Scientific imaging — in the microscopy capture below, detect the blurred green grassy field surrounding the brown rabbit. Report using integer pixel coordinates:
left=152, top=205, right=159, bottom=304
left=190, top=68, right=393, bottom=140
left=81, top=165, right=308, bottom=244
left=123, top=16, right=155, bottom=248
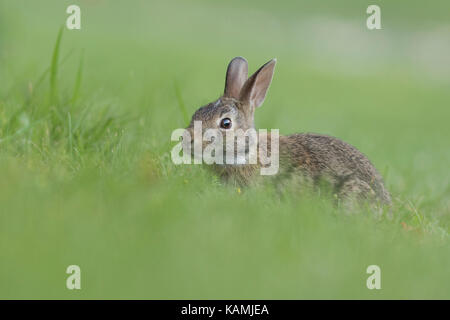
left=0, top=0, right=450, bottom=299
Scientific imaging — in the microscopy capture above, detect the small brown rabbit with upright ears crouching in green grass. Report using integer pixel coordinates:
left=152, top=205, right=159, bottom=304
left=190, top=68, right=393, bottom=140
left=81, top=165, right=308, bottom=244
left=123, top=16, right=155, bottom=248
left=185, top=57, right=391, bottom=204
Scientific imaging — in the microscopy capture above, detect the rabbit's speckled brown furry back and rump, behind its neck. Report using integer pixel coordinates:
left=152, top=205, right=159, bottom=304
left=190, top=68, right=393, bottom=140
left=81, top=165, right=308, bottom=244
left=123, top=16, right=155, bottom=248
left=280, top=133, right=391, bottom=203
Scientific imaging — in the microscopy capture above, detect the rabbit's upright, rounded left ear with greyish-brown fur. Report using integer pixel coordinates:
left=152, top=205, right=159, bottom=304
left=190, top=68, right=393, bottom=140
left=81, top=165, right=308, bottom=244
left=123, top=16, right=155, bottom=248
left=224, top=57, right=248, bottom=99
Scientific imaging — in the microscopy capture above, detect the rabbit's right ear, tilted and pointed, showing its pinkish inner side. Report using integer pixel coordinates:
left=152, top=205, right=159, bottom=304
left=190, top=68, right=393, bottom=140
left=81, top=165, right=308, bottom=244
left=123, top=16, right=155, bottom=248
left=239, top=59, right=277, bottom=108
